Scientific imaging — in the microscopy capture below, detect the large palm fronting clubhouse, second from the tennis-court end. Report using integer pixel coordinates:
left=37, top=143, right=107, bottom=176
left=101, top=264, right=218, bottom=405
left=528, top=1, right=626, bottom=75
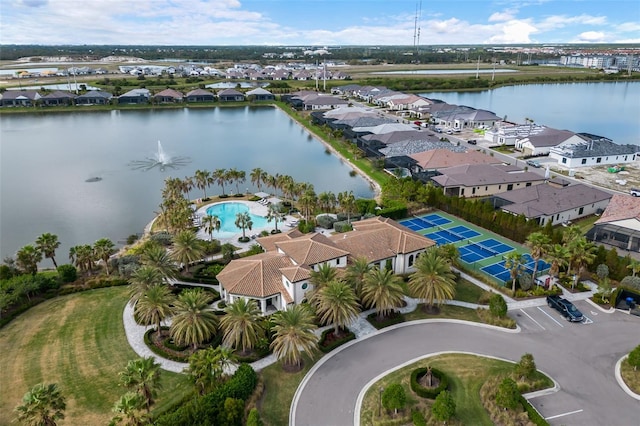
left=362, top=268, right=403, bottom=321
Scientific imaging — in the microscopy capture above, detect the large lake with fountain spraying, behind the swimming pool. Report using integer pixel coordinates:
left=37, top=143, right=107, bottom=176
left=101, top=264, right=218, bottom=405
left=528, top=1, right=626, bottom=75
left=0, top=107, right=373, bottom=260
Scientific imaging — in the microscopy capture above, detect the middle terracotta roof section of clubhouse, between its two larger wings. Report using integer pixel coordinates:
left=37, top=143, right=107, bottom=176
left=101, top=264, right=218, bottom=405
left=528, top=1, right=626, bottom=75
left=275, top=233, right=349, bottom=266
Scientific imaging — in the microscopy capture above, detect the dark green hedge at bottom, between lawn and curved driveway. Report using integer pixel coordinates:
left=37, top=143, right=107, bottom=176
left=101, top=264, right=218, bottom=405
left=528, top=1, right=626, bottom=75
left=154, top=364, right=258, bottom=426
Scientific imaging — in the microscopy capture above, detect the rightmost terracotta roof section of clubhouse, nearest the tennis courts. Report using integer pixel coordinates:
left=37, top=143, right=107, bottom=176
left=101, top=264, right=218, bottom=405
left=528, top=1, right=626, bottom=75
left=330, top=217, right=436, bottom=262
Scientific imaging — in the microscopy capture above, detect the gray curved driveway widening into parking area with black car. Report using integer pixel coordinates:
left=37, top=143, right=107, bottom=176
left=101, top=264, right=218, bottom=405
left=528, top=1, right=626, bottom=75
left=290, top=313, right=640, bottom=426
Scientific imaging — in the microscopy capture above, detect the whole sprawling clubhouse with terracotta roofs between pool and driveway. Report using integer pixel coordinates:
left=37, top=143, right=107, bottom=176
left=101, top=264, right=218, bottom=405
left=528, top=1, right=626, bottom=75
left=217, top=217, right=435, bottom=314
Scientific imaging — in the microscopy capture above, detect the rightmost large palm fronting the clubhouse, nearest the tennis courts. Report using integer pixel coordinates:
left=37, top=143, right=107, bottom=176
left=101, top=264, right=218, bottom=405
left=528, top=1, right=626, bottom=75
left=409, top=250, right=456, bottom=310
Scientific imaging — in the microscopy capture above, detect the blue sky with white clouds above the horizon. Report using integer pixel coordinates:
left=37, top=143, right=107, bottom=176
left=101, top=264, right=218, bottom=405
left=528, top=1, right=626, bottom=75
left=0, top=0, right=640, bottom=46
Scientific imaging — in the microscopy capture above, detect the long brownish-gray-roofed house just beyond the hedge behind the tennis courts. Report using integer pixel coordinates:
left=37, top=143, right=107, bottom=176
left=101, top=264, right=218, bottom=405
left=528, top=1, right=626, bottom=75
left=493, top=183, right=612, bottom=226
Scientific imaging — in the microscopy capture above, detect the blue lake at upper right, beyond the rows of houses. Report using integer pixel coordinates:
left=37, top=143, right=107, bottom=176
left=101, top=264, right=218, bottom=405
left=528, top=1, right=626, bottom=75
left=420, top=82, right=640, bottom=145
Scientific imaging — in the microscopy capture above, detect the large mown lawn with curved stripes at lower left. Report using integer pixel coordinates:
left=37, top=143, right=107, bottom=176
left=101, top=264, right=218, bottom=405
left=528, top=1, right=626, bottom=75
left=0, top=287, right=191, bottom=425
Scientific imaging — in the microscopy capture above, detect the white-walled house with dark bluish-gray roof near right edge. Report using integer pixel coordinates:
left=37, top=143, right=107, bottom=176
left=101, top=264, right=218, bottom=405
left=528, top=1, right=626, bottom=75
left=549, top=133, right=640, bottom=168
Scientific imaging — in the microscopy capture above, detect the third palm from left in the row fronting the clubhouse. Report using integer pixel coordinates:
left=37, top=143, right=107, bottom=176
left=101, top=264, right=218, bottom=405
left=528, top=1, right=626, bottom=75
left=220, top=297, right=264, bottom=355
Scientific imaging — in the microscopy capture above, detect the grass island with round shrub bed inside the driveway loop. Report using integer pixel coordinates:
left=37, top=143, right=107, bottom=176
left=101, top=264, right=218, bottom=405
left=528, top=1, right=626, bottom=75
left=360, top=354, right=551, bottom=426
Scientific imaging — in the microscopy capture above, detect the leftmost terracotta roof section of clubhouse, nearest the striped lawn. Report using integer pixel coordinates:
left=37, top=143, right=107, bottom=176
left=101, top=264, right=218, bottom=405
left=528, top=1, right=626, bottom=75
left=217, top=252, right=294, bottom=303
